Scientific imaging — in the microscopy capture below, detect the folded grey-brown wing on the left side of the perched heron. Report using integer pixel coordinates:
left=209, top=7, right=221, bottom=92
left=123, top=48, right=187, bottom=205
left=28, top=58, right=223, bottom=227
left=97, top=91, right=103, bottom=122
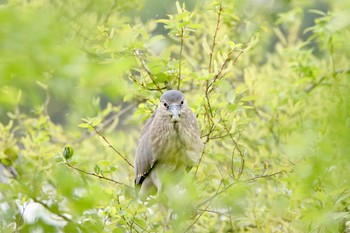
left=134, top=110, right=157, bottom=185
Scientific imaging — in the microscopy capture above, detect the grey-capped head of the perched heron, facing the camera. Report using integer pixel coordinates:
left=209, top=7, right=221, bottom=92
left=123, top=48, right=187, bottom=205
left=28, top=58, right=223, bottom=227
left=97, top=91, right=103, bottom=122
left=160, top=90, right=186, bottom=122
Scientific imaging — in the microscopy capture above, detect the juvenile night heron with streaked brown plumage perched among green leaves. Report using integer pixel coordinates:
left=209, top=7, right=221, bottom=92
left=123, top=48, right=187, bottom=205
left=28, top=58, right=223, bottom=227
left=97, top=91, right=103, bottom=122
left=134, top=90, right=203, bottom=201
